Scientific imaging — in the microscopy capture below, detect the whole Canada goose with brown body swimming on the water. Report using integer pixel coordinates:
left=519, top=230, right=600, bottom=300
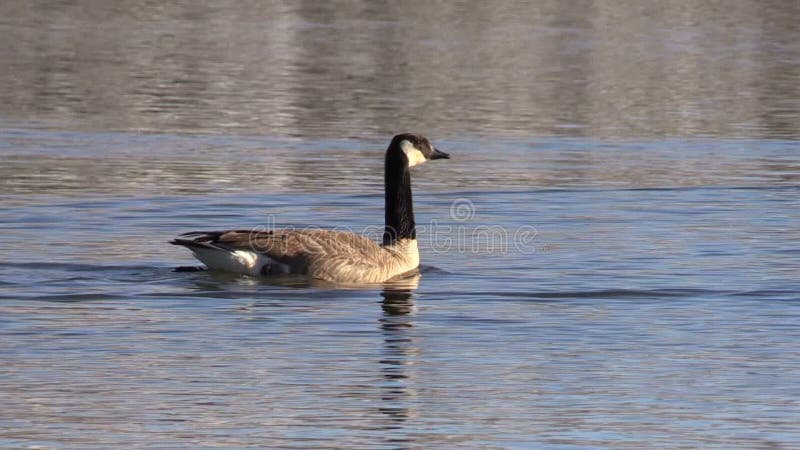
left=170, top=133, right=450, bottom=283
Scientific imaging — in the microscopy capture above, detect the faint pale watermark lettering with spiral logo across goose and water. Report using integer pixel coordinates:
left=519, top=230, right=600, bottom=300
left=250, top=198, right=537, bottom=253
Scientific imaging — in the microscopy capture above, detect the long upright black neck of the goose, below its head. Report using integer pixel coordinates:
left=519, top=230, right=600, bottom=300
left=383, top=152, right=417, bottom=245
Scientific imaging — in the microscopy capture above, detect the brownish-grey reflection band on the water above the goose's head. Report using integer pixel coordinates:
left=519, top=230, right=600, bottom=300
left=0, top=0, right=800, bottom=138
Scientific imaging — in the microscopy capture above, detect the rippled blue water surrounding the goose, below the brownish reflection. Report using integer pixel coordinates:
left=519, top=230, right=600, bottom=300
left=0, top=130, right=800, bottom=448
